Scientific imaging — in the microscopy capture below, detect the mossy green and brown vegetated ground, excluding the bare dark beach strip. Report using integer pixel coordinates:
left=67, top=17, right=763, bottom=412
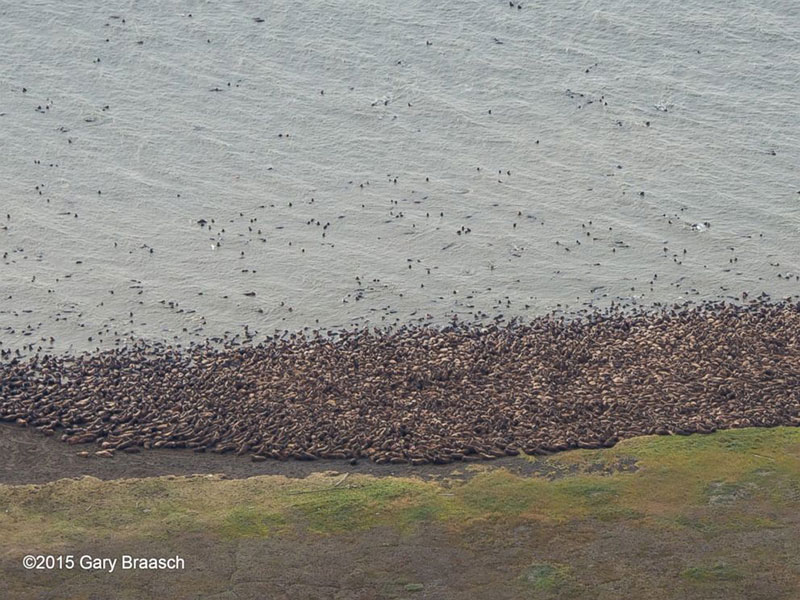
left=0, top=428, right=800, bottom=598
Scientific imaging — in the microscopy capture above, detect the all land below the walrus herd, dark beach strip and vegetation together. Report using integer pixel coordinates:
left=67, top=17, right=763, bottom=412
left=0, top=427, right=800, bottom=600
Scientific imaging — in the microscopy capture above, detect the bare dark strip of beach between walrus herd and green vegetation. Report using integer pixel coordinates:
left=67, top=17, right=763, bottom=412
left=0, top=423, right=797, bottom=486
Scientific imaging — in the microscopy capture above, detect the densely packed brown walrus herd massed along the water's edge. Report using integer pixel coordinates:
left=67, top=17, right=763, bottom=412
left=0, top=301, right=800, bottom=464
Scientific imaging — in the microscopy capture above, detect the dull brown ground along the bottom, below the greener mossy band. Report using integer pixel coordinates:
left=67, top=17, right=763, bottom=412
left=0, top=521, right=800, bottom=600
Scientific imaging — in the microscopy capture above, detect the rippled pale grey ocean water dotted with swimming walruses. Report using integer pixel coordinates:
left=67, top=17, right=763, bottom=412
left=0, top=0, right=800, bottom=352
